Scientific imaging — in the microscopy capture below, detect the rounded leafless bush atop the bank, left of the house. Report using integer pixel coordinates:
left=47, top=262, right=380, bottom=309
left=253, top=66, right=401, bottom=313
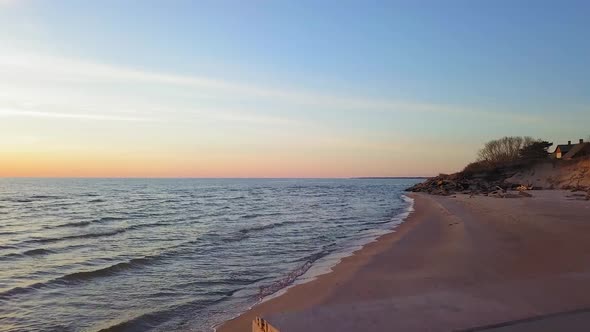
left=478, top=136, right=537, bottom=165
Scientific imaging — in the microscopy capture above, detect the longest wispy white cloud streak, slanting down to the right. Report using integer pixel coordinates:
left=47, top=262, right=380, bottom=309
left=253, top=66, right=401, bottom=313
left=0, top=54, right=543, bottom=123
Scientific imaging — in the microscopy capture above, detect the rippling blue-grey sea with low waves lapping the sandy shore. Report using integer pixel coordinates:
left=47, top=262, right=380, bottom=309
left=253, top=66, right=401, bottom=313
left=0, top=179, right=416, bottom=331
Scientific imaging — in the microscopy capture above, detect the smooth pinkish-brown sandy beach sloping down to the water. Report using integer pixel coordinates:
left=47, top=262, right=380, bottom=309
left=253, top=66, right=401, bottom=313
left=217, top=191, right=590, bottom=332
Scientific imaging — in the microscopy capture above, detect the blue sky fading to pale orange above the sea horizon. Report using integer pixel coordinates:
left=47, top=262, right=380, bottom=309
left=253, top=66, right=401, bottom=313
left=0, top=0, right=590, bottom=177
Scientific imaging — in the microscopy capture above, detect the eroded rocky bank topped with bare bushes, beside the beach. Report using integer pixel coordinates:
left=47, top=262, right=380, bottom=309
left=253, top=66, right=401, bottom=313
left=408, top=136, right=590, bottom=200
